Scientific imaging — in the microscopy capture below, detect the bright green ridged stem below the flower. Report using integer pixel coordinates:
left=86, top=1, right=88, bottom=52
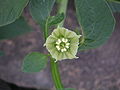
left=50, top=58, right=63, bottom=90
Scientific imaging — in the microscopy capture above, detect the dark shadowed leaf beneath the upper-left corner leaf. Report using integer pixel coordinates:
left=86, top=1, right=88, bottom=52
left=0, top=17, right=32, bottom=40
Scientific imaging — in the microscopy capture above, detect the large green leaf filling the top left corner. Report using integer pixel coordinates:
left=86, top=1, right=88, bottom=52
left=0, top=0, right=29, bottom=26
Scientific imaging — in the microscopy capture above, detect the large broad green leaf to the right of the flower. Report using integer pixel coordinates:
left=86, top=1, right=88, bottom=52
left=75, top=0, right=115, bottom=50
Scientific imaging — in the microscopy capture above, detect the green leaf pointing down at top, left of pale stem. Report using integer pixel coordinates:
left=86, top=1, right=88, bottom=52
left=29, top=0, right=55, bottom=29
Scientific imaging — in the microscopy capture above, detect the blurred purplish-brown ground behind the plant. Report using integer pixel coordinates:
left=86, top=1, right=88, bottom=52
left=0, top=0, right=120, bottom=90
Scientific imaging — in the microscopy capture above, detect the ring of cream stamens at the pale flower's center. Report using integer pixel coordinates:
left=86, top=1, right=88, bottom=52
left=56, top=38, right=70, bottom=52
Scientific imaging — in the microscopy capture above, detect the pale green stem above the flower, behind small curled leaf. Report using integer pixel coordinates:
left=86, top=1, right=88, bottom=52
left=58, top=0, right=68, bottom=26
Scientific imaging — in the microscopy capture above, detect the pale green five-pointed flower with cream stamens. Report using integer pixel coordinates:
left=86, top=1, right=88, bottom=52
left=45, top=27, right=81, bottom=61
